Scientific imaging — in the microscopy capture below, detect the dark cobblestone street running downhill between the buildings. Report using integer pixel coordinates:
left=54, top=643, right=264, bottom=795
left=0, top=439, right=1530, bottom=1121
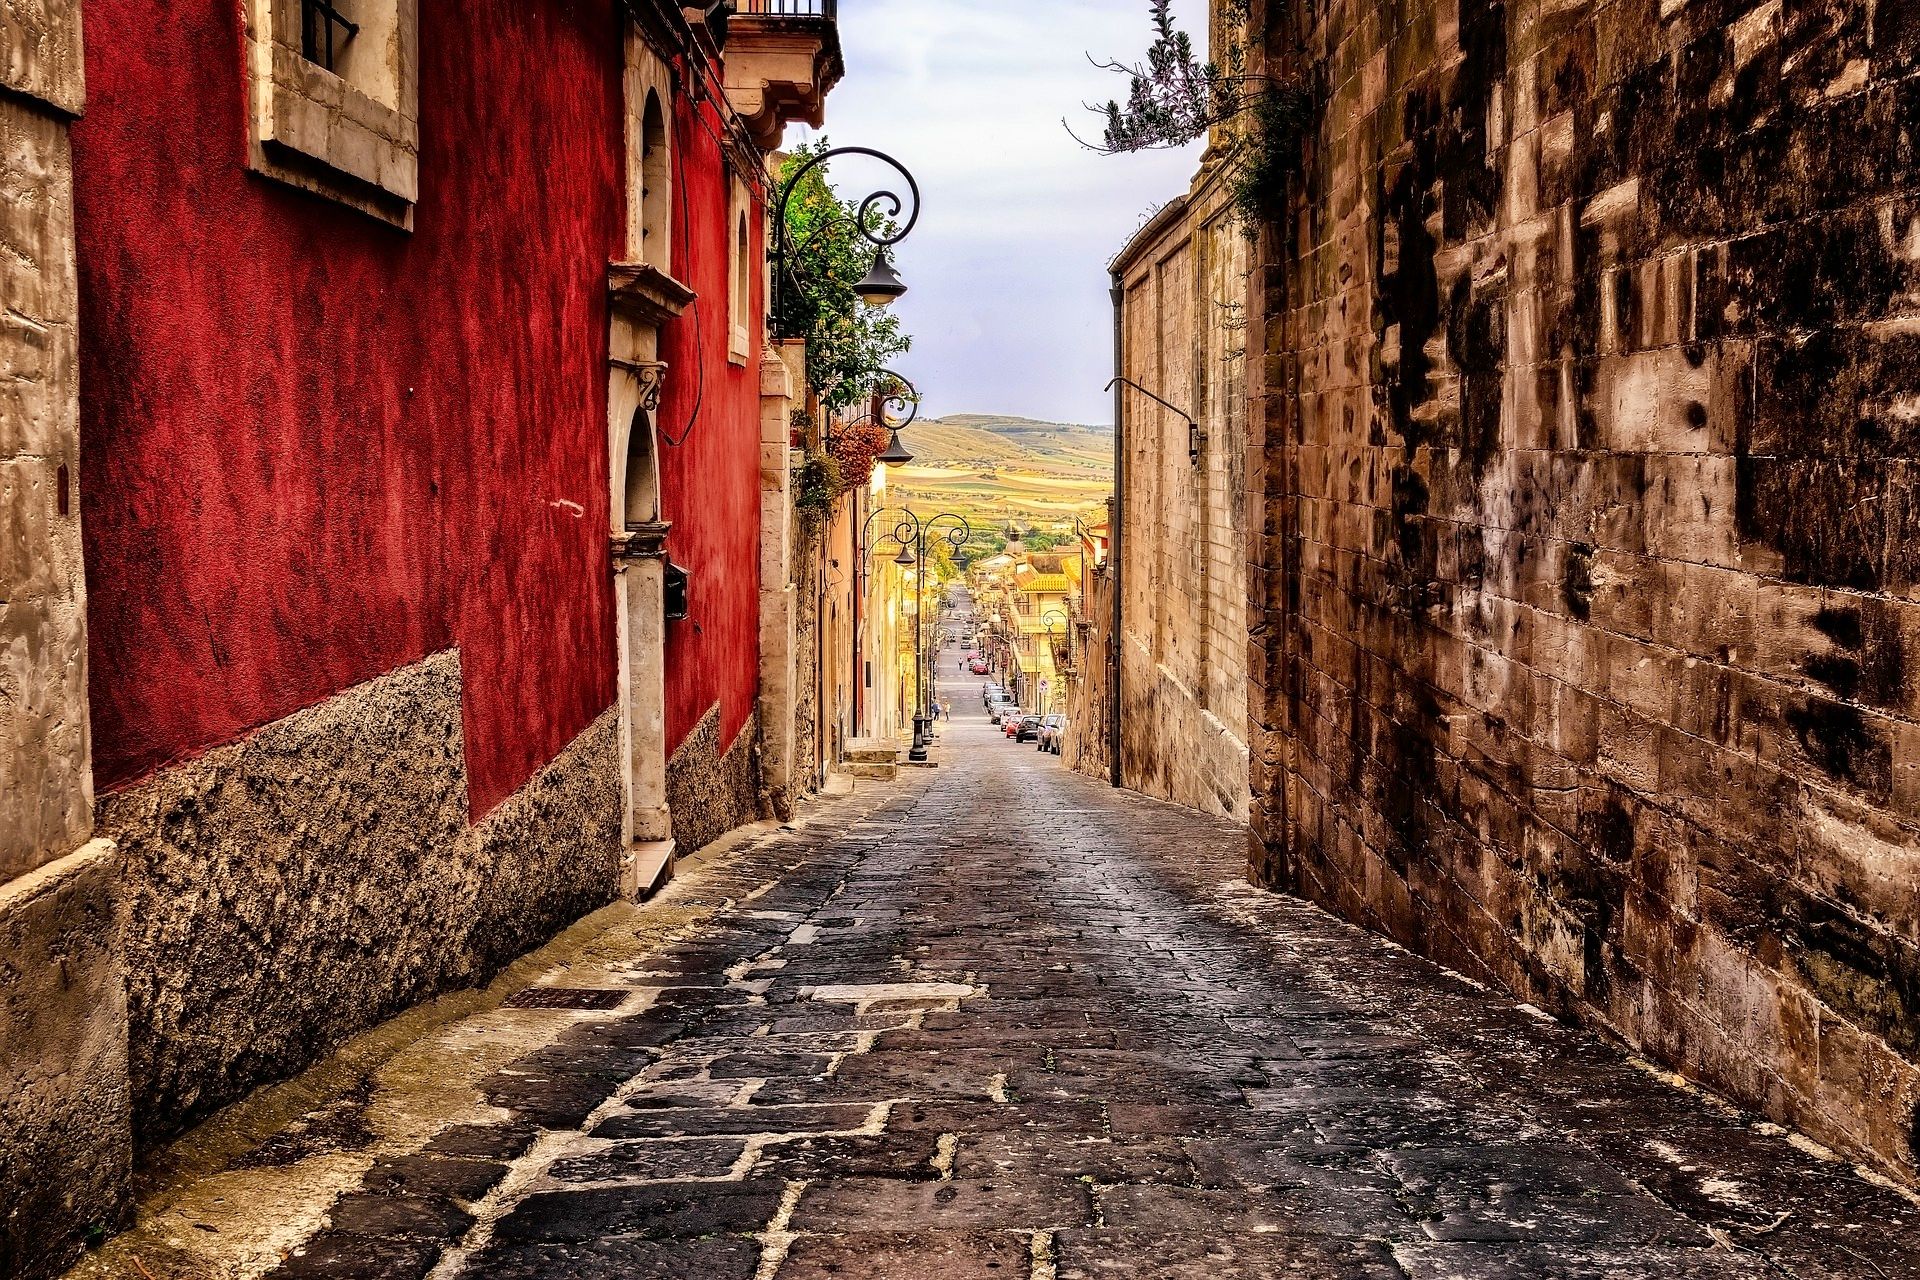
left=82, top=667, right=1920, bottom=1280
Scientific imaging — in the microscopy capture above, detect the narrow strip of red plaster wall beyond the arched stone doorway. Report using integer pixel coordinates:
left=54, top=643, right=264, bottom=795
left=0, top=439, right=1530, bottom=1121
left=659, top=104, right=766, bottom=750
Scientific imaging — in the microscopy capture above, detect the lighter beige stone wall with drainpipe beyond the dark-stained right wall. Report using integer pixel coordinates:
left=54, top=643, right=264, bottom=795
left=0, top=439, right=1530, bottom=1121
left=1114, top=167, right=1248, bottom=819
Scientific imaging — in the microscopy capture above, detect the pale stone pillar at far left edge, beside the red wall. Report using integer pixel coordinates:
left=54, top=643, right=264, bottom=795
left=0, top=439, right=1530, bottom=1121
left=0, top=0, right=132, bottom=1280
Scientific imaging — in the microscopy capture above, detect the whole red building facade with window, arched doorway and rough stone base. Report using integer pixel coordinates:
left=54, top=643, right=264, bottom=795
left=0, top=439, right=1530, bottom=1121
left=0, top=0, right=839, bottom=1274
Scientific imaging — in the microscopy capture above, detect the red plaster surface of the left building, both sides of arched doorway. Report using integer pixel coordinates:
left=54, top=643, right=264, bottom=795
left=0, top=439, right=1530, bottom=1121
left=75, top=0, right=756, bottom=816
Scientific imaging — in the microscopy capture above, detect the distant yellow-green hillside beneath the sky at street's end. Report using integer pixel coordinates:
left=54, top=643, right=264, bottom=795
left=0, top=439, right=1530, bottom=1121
left=887, top=413, right=1114, bottom=545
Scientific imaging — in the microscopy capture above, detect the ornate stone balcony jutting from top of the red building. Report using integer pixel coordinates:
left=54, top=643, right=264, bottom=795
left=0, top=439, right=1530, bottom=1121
left=726, top=0, right=847, bottom=152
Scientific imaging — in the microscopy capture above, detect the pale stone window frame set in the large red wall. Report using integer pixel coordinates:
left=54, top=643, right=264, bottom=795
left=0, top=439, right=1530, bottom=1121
left=246, top=0, right=420, bottom=230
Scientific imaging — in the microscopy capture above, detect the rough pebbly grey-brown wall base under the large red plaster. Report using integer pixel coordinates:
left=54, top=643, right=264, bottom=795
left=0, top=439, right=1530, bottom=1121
left=100, top=652, right=622, bottom=1144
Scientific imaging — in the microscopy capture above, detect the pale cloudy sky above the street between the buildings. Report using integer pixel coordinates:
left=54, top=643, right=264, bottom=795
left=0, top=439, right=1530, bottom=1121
left=787, top=0, right=1206, bottom=422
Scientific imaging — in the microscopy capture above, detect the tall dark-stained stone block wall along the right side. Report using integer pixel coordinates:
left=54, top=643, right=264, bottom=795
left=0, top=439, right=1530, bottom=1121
left=1248, top=0, right=1920, bottom=1174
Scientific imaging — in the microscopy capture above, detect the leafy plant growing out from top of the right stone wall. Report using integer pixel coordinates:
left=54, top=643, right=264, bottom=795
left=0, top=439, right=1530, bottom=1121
left=1068, top=0, right=1311, bottom=226
